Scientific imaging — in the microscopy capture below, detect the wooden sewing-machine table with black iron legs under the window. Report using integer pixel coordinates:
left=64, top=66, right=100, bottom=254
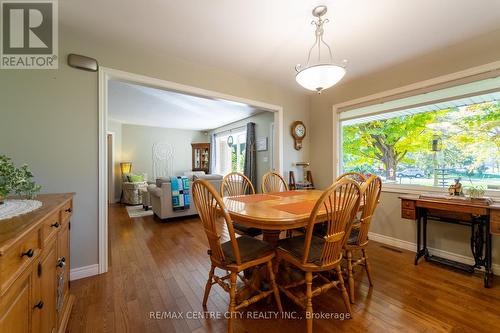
left=400, top=195, right=500, bottom=288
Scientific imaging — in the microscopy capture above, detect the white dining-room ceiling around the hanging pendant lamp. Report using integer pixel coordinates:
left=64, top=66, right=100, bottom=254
left=59, top=0, right=500, bottom=88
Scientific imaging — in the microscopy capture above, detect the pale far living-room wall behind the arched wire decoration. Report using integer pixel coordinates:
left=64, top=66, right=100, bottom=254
left=122, top=124, right=209, bottom=180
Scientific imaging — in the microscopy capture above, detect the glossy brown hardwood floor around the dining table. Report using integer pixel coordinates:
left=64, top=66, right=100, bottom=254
left=68, top=205, right=500, bottom=333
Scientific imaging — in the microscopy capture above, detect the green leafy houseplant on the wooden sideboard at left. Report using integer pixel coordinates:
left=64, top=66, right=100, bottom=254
left=0, top=155, right=41, bottom=204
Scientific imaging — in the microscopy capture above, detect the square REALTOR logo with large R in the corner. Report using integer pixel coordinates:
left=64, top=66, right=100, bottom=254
left=0, top=0, right=59, bottom=69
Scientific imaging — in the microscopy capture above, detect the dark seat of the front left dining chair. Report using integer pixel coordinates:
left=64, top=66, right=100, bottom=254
left=221, top=236, right=274, bottom=263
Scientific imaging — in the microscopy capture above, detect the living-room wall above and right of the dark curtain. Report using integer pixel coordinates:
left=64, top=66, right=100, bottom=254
left=209, top=111, right=276, bottom=192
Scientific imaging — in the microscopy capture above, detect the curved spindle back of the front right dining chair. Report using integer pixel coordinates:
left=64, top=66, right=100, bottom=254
left=302, top=179, right=361, bottom=266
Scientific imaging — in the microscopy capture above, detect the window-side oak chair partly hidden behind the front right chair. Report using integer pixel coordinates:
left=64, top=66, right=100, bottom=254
left=344, top=175, right=382, bottom=303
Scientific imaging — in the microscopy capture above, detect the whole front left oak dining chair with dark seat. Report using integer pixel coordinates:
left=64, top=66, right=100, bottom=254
left=192, top=179, right=283, bottom=332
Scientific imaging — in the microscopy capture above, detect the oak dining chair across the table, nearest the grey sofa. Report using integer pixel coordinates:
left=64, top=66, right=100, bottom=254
left=220, top=172, right=262, bottom=237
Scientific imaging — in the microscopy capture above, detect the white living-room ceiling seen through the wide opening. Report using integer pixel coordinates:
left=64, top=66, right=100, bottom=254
left=108, top=80, right=263, bottom=130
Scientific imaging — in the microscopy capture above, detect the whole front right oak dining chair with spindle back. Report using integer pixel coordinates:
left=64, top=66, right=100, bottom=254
left=275, top=179, right=361, bottom=333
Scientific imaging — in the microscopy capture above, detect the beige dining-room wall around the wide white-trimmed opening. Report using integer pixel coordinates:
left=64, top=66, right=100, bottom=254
left=0, top=18, right=309, bottom=268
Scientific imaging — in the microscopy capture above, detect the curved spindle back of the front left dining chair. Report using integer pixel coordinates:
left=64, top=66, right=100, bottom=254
left=192, top=179, right=241, bottom=265
